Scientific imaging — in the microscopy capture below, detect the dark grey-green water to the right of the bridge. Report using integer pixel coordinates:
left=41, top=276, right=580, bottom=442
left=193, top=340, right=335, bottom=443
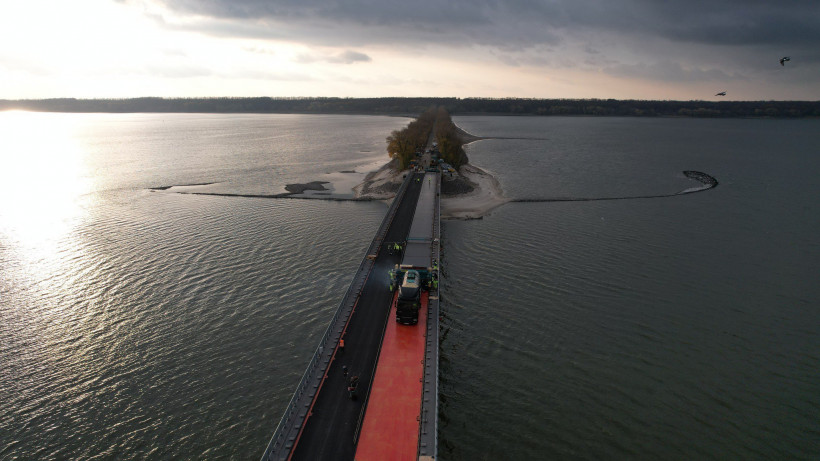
left=441, top=117, right=820, bottom=460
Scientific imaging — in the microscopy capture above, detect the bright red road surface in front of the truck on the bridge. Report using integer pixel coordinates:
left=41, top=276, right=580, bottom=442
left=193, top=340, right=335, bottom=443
left=354, top=291, right=428, bottom=461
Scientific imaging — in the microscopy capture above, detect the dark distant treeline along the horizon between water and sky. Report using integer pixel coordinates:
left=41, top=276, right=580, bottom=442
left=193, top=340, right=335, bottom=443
left=0, top=97, right=820, bottom=118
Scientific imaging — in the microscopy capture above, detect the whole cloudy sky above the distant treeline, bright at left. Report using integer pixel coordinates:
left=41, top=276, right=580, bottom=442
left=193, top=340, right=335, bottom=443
left=0, top=0, right=820, bottom=101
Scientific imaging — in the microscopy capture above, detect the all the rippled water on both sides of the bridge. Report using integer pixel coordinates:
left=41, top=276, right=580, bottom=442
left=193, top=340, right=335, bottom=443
left=0, top=113, right=820, bottom=460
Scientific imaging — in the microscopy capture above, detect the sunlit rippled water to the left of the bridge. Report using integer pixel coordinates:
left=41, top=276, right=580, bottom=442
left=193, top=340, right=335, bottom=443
left=0, top=113, right=406, bottom=459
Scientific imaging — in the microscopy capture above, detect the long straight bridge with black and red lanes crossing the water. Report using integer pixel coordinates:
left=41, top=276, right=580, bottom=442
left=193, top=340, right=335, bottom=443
left=262, top=165, right=441, bottom=461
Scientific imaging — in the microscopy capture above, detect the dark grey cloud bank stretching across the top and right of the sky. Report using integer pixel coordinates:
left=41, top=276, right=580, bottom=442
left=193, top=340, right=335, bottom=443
left=139, top=0, right=820, bottom=88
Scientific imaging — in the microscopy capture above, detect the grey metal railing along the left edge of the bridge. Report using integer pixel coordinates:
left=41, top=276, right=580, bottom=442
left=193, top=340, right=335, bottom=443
left=262, top=174, right=412, bottom=461
